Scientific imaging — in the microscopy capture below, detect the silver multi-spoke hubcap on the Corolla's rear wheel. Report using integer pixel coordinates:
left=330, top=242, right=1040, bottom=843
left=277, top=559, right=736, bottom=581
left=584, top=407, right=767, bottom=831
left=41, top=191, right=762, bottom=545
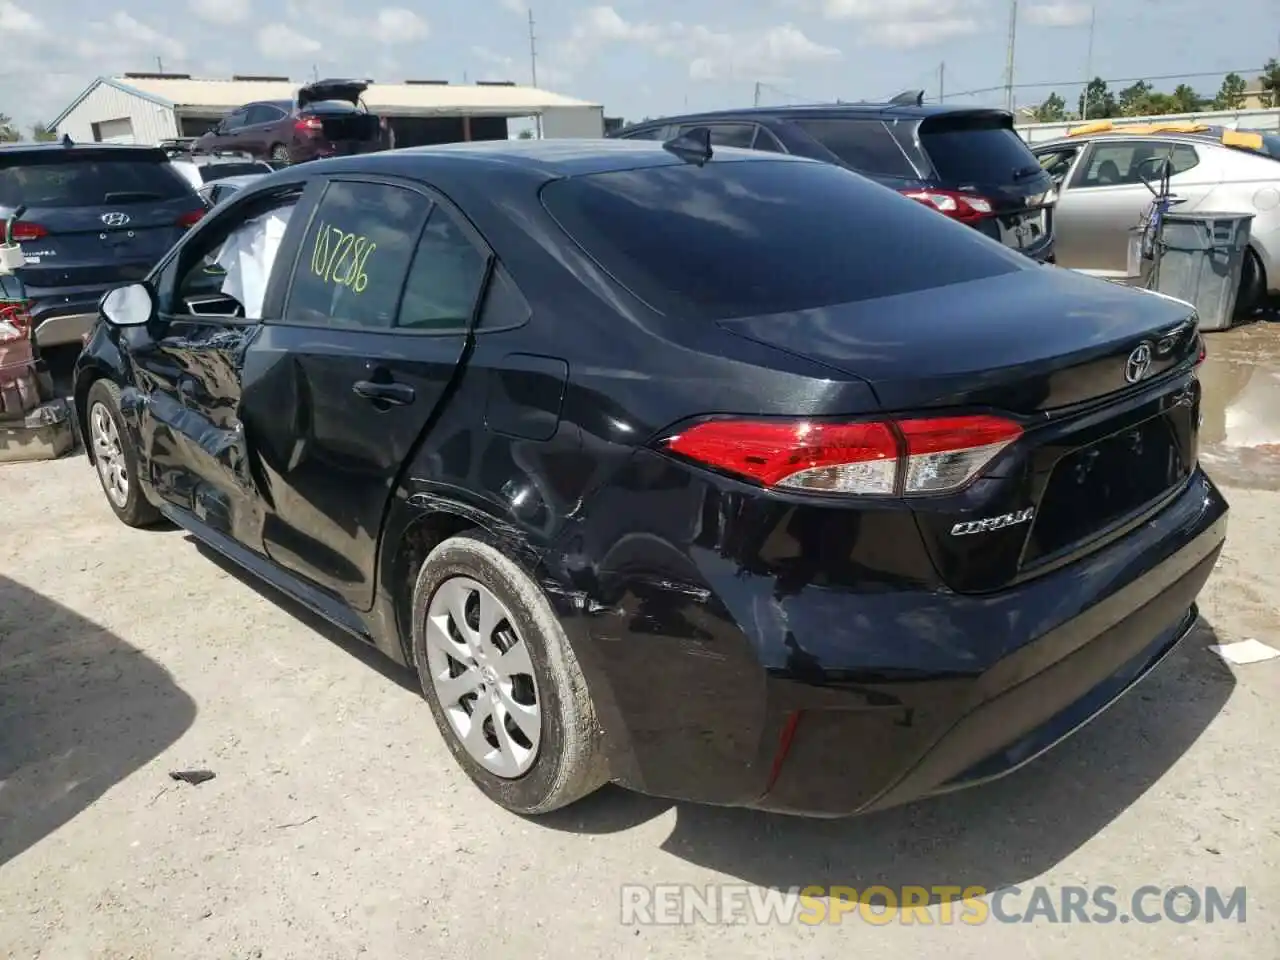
left=426, top=577, right=543, bottom=780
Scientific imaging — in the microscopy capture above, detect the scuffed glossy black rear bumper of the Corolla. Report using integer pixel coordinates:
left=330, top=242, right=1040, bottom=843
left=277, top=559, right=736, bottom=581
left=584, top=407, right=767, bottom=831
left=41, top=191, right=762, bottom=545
left=557, top=471, right=1228, bottom=817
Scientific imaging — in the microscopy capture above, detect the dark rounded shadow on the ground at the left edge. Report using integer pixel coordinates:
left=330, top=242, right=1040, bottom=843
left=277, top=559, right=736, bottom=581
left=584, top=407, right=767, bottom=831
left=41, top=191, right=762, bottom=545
left=0, top=576, right=196, bottom=865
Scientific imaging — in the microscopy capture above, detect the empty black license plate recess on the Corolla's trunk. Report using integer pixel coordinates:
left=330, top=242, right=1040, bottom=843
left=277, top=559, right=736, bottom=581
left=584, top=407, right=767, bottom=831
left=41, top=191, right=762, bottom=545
left=1023, top=406, right=1196, bottom=566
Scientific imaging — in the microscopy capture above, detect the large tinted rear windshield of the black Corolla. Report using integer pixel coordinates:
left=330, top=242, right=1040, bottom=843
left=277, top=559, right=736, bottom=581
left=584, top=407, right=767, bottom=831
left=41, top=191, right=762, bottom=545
left=543, top=159, right=1023, bottom=323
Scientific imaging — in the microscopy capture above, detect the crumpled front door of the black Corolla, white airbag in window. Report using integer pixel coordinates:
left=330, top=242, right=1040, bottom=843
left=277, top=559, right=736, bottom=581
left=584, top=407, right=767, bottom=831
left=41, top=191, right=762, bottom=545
left=123, top=179, right=321, bottom=550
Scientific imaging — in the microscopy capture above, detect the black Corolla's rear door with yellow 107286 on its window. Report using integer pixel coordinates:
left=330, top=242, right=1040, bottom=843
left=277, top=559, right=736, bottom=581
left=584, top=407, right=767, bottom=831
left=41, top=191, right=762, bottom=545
left=242, top=177, right=492, bottom=609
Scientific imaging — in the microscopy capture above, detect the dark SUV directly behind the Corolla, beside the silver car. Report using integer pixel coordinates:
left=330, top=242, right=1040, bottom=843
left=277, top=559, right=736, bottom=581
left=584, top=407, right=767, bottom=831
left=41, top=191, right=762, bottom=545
left=611, top=91, right=1057, bottom=262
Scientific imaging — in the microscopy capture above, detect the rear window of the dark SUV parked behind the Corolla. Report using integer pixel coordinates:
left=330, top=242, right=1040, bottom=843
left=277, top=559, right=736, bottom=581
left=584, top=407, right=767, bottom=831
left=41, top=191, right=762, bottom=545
left=920, top=115, right=1039, bottom=183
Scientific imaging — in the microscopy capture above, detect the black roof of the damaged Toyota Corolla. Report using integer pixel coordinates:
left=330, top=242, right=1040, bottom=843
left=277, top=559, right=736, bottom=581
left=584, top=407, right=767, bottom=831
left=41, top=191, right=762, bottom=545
left=307, top=138, right=817, bottom=179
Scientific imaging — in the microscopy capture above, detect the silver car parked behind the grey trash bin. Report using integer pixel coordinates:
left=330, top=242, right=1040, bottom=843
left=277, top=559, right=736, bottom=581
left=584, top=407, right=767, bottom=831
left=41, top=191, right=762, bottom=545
left=1032, top=123, right=1280, bottom=316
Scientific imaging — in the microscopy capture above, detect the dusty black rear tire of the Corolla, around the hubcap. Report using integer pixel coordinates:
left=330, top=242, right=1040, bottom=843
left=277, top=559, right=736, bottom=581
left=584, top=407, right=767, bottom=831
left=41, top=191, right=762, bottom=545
left=412, top=531, right=609, bottom=815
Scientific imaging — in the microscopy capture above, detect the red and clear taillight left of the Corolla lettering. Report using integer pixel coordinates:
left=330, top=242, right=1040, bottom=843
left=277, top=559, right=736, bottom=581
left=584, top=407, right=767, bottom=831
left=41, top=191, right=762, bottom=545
left=663, top=416, right=1023, bottom=497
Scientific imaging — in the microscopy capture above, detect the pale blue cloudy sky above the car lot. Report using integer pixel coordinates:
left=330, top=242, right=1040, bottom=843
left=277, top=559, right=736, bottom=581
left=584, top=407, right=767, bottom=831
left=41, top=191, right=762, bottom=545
left=0, top=0, right=1280, bottom=125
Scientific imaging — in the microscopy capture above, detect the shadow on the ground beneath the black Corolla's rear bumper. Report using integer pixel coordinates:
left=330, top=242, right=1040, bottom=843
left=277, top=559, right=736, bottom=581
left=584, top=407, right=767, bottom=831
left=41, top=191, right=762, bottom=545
left=536, top=620, right=1235, bottom=891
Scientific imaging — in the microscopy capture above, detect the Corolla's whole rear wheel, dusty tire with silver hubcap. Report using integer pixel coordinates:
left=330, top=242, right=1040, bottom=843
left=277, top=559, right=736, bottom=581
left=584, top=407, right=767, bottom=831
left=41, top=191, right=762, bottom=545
left=413, top=534, right=608, bottom=814
